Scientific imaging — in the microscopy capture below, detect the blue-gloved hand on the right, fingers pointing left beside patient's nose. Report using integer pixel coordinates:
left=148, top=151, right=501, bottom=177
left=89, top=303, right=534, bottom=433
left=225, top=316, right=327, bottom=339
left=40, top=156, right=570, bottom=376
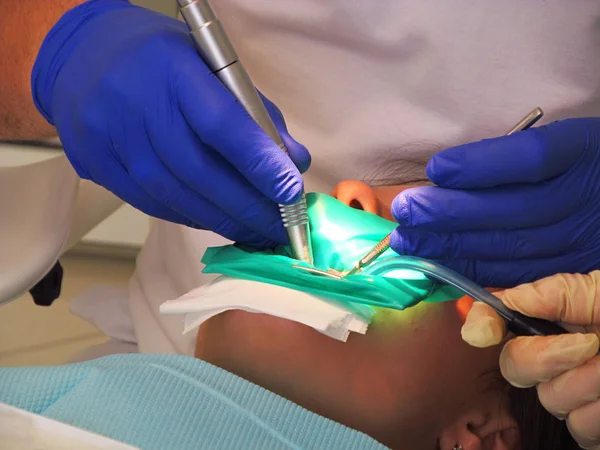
left=391, top=118, right=600, bottom=287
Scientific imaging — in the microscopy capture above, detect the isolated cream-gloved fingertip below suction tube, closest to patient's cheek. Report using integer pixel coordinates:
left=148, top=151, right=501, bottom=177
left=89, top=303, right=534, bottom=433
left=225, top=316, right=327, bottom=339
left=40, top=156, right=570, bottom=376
left=461, top=302, right=506, bottom=348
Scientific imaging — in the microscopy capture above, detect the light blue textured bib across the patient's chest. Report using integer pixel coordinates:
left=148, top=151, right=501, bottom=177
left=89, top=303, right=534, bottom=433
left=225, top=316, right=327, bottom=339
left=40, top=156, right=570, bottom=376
left=0, top=354, right=385, bottom=450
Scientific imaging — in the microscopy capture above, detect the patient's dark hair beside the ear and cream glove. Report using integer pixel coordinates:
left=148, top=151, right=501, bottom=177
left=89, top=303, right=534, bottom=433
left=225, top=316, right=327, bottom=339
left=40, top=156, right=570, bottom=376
left=508, top=386, right=580, bottom=450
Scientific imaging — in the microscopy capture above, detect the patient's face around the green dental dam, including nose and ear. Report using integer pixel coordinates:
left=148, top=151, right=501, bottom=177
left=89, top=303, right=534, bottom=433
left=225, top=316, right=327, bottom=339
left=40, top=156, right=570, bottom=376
left=196, top=184, right=517, bottom=450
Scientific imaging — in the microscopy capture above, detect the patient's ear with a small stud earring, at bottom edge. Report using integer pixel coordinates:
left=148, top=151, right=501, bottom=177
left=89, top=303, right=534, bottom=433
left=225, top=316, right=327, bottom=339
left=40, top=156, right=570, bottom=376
left=440, top=408, right=520, bottom=450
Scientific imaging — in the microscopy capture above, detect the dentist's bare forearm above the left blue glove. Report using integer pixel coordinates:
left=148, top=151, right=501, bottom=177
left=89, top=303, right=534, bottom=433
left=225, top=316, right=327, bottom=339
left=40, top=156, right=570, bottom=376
left=0, top=0, right=85, bottom=139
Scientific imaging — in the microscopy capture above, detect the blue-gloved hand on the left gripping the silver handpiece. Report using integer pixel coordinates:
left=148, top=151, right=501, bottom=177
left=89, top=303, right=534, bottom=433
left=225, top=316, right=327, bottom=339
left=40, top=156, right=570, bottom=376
left=32, top=0, right=310, bottom=250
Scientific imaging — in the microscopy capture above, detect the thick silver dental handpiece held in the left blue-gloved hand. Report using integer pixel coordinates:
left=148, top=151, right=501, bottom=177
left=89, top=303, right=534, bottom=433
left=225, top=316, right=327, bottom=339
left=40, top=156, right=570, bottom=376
left=177, top=0, right=313, bottom=264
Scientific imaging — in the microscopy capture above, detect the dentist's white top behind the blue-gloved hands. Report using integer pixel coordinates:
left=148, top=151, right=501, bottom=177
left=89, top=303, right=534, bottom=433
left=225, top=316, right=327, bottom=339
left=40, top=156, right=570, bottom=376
left=4, top=0, right=600, bottom=353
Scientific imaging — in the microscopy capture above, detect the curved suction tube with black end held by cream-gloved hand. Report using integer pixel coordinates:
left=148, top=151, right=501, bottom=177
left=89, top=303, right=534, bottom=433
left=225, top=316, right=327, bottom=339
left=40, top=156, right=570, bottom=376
left=363, top=256, right=568, bottom=336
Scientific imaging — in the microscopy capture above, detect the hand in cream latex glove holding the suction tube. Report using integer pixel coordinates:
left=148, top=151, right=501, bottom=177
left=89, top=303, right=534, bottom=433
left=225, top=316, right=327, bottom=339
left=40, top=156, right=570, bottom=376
left=462, top=271, right=600, bottom=449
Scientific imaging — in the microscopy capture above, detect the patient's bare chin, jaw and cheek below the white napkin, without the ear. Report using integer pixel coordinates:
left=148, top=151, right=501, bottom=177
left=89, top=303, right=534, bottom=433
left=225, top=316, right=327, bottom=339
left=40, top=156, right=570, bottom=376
left=196, top=303, right=497, bottom=448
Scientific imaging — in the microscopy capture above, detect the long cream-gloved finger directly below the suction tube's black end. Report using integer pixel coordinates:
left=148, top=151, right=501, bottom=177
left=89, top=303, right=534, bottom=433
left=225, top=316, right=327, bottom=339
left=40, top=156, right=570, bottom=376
left=500, top=334, right=599, bottom=387
